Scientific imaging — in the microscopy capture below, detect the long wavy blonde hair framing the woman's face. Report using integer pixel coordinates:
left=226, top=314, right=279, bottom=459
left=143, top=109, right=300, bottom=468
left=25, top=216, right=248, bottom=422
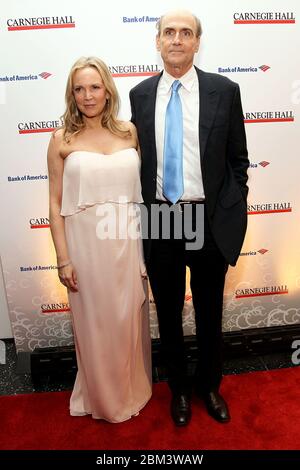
left=62, top=57, right=131, bottom=142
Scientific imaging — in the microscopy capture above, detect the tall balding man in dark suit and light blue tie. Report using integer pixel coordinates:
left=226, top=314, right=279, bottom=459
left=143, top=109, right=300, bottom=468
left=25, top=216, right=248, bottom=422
left=130, top=11, right=249, bottom=426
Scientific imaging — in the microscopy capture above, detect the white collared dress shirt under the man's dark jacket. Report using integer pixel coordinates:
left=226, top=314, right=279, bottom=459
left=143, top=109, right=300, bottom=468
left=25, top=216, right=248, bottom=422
left=155, top=67, right=205, bottom=201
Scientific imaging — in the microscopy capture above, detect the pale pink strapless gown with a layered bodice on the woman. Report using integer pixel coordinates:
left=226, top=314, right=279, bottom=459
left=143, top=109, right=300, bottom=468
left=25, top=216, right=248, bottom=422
left=61, top=148, right=152, bottom=423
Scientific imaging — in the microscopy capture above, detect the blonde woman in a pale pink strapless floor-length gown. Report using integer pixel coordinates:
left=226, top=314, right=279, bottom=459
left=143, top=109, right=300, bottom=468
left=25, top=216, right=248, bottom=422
left=48, top=57, right=151, bottom=423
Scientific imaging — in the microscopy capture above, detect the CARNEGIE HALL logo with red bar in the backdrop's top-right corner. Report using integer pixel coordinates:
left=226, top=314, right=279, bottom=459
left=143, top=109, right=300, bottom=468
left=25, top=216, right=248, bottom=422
left=233, top=11, right=296, bottom=24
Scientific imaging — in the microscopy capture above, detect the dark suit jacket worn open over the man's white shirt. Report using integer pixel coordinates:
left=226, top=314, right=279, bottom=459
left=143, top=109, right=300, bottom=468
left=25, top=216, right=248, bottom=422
left=130, top=67, right=249, bottom=266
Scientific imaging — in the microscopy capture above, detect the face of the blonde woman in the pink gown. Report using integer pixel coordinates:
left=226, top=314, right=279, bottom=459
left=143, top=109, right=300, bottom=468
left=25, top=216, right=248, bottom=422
left=73, top=67, right=109, bottom=118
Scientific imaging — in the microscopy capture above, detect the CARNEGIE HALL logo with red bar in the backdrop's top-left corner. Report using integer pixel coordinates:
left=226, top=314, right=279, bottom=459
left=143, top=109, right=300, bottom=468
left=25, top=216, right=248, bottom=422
left=6, top=16, right=75, bottom=31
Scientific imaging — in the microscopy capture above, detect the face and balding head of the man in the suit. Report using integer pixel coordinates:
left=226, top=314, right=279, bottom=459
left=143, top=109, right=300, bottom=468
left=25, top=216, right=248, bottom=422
left=156, top=13, right=200, bottom=76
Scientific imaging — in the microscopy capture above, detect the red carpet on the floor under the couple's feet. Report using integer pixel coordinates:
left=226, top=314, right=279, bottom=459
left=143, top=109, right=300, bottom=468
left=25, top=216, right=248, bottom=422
left=0, top=367, right=300, bottom=450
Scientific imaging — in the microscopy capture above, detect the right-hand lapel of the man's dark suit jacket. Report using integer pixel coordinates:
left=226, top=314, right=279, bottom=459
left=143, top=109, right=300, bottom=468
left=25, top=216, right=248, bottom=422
left=195, top=67, right=220, bottom=160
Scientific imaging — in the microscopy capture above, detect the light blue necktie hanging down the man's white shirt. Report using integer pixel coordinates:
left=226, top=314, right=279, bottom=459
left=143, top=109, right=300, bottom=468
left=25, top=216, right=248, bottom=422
left=163, top=80, right=183, bottom=204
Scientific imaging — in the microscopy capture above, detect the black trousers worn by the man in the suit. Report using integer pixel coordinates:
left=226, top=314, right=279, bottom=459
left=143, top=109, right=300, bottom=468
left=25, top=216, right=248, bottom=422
left=147, top=206, right=228, bottom=393
